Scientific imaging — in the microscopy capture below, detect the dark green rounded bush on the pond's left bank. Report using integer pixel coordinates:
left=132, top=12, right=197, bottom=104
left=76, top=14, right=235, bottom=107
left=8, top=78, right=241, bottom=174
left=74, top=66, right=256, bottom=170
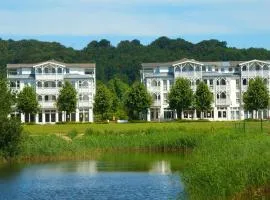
left=0, top=119, right=23, bottom=159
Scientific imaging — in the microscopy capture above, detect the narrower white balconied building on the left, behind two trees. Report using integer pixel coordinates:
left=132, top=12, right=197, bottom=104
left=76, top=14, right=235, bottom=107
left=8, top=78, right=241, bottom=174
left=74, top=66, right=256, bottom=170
left=7, top=60, right=96, bottom=124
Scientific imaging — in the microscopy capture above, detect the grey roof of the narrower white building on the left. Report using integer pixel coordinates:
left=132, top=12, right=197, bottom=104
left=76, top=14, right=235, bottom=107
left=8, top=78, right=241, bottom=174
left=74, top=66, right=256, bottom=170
left=7, top=60, right=96, bottom=69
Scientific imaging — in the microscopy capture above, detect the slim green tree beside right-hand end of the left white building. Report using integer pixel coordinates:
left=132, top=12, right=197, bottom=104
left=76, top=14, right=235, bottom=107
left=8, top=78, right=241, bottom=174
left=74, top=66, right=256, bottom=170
left=94, top=83, right=113, bottom=120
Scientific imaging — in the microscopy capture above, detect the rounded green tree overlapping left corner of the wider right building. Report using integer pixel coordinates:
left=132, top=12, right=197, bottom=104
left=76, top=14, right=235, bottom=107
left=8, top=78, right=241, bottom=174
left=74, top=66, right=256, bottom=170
left=125, top=82, right=152, bottom=119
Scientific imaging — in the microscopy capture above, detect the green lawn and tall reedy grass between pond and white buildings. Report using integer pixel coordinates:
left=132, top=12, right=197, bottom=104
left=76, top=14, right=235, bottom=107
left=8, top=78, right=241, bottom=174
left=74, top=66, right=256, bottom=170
left=5, top=121, right=270, bottom=199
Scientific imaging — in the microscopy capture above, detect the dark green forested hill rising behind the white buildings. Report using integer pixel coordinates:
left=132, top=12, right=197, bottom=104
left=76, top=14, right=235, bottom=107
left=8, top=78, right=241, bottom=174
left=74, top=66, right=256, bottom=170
left=0, top=37, right=270, bottom=83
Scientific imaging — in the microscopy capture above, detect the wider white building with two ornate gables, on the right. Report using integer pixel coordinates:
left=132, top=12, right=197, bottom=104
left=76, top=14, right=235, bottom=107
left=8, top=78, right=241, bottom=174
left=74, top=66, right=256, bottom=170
left=141, top=59, right=270, bottom=121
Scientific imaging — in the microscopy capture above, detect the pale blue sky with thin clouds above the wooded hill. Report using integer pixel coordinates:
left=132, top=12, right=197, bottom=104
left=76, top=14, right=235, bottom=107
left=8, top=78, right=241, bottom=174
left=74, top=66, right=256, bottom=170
left=0, top=0, right=270, bottom=49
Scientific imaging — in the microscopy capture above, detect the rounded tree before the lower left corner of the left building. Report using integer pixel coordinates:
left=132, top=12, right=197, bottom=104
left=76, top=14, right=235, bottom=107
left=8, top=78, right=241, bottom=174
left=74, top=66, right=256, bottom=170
left=17, top=86, right=39, bottom=122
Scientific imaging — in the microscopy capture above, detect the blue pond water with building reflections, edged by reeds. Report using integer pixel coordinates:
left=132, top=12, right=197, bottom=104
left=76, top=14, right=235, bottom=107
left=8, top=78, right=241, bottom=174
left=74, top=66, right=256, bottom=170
left=0, top=153, right=184, bottom=200
